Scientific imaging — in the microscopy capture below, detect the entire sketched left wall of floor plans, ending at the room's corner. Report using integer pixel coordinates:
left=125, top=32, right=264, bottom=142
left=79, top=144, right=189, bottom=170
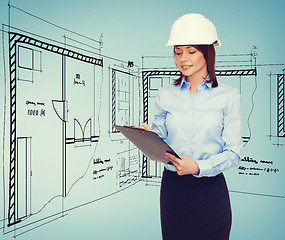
left=1, top=13, right=140, bottom=236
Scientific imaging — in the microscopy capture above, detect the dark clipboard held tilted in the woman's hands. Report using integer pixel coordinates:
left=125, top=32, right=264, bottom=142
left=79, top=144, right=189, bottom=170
left=114, top=125, right=180, bottom=163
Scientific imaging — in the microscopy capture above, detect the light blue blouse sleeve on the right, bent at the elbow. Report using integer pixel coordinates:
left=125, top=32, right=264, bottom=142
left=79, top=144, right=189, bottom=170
left=194, top=91, right=242, bottom=177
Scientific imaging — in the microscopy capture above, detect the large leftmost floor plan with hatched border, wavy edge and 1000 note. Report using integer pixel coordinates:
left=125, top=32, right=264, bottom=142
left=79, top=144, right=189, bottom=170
left=8, top=30, right=103, bottom=229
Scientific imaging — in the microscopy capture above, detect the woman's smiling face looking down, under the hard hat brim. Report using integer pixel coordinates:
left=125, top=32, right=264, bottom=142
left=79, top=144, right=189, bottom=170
left=174, top=45, right=208, bottom=81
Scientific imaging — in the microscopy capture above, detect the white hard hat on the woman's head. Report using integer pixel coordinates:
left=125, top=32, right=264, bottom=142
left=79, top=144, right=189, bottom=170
left=166, top=13, right=221, bottom=47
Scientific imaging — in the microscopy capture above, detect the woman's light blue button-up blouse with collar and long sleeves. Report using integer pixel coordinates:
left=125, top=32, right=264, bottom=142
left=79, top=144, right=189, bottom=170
left=152, top=78, right=242, bottom=177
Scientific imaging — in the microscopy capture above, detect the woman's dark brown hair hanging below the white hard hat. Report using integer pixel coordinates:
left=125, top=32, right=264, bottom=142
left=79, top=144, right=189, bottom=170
left=173, top=44, right=218, bottom=87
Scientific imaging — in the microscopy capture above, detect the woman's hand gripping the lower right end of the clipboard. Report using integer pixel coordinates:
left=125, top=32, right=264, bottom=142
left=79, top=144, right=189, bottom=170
left=165, top=153, right=200, bottom=175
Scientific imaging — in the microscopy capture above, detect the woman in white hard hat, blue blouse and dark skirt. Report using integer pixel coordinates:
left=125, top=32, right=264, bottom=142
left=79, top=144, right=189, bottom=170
left=142, top=14, right=242, bottom=240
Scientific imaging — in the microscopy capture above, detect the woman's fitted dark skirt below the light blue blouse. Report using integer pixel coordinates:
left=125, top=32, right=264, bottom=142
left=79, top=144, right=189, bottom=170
left=160, top=169, right=232, bottom=240
